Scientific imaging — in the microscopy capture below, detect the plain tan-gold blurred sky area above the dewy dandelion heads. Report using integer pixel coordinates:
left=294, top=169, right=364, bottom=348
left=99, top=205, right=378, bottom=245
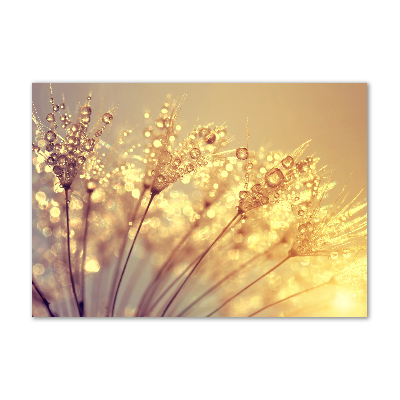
left=32, top=83, right=367, bottom=197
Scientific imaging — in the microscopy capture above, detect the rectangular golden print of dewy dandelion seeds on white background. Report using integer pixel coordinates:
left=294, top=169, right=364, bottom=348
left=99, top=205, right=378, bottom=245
left=32, top=83, right=367, bottom=317
